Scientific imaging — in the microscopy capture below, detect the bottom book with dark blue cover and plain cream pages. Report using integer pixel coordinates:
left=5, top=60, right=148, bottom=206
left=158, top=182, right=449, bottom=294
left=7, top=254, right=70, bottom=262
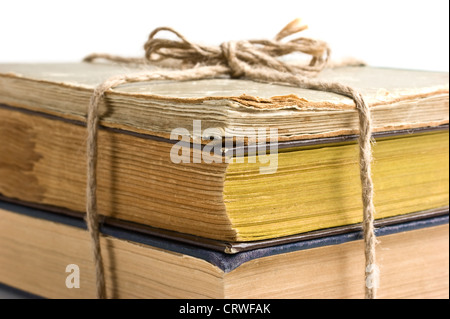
left=0, top=202, right=449, bottom=299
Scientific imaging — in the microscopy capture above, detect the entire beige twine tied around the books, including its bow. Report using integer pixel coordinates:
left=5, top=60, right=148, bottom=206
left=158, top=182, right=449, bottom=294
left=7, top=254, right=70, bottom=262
left=84, top=19, right=379, bottom=299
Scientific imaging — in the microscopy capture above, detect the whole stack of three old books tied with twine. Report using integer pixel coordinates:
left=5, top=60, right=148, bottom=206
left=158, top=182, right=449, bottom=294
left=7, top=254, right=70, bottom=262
left=0, top=63, right=449, bottom=298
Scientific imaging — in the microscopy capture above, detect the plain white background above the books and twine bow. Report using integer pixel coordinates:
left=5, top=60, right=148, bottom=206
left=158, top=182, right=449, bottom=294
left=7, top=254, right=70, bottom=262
left=0, top=0, right=449, bottom=71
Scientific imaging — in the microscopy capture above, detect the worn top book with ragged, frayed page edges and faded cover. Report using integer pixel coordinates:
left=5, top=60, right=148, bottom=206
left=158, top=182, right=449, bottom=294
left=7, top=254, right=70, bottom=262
left=0, top=63, right=449, bottom=141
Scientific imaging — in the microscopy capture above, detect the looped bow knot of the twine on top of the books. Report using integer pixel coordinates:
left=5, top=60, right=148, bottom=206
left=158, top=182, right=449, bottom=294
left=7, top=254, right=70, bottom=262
left=144, top=19, right=330, bottom=78
